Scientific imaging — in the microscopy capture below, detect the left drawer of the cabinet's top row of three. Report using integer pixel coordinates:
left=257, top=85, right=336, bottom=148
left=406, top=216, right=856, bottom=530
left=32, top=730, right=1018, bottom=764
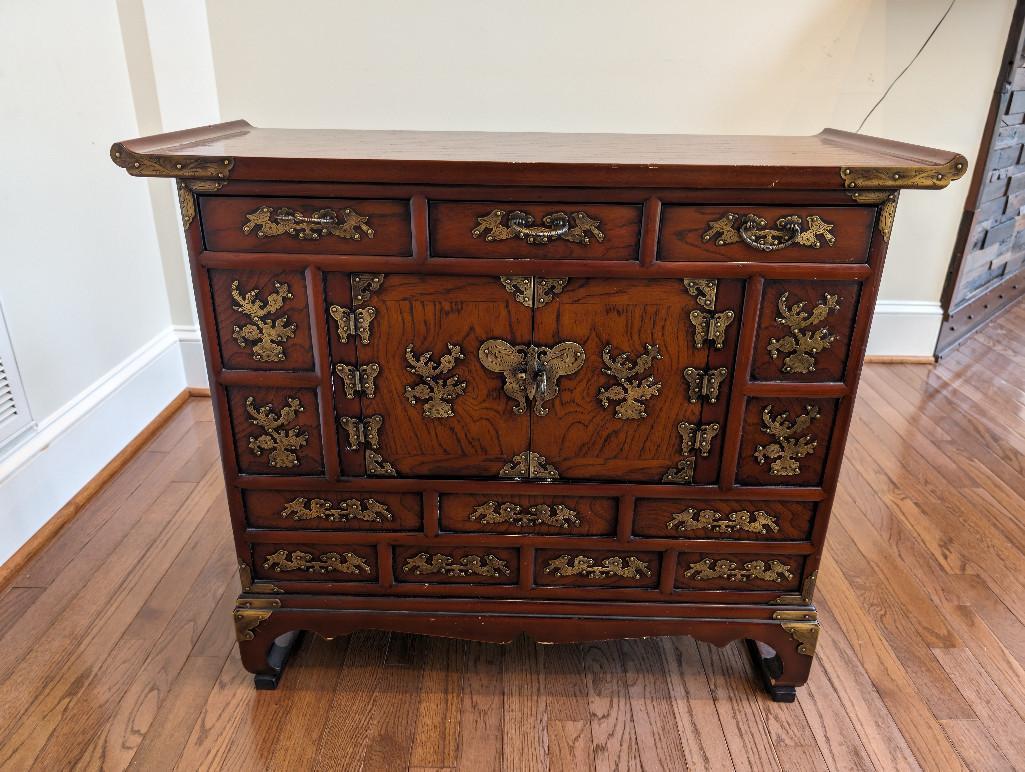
left=200, top=196, right=412, bottom=256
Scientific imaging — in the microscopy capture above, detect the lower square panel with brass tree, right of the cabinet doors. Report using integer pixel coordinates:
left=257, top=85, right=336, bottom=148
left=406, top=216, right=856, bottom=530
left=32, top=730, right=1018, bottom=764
left=737, top=397, right=837, bottom=486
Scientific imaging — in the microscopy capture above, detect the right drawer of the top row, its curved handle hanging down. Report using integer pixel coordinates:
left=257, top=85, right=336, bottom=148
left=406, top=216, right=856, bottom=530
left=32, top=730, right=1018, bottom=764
left=658, top=204, right=875, bottom=262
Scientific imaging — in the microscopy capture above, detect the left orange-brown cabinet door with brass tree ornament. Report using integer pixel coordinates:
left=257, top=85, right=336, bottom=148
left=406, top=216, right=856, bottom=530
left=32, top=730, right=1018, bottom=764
left=335, top=274, right=531, bottom=477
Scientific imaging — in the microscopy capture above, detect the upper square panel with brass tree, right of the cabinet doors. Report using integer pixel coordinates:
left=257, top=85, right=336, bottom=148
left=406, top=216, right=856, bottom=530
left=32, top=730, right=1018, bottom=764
left=751, top=280, right=861, bottom=382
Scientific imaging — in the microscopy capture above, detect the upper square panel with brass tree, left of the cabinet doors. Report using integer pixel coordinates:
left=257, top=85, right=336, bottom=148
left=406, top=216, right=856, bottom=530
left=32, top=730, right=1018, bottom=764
left=209, top=271, right=314, bottom=370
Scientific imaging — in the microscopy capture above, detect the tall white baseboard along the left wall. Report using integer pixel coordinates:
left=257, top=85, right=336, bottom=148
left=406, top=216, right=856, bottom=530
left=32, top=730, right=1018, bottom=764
left=0, top=328, right=188, bottom=563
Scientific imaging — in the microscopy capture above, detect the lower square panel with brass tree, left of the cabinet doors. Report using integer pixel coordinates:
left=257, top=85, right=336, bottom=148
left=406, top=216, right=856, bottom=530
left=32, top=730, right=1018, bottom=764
left=226, top=387, right=324, bottom=475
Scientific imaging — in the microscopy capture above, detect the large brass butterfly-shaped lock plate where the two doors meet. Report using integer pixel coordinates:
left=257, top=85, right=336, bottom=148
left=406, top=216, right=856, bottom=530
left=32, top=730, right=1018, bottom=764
left=478, top=338, right=585, bottom=416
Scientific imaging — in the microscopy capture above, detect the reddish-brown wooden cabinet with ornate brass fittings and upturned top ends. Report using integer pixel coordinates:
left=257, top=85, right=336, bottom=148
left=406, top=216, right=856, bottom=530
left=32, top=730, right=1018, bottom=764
left=111, top=121, right=966, bottom=700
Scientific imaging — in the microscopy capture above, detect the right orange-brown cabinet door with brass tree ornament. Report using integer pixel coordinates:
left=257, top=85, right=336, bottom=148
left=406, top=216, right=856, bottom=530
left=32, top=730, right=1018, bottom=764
left=531, top=278, right=739, bottom=484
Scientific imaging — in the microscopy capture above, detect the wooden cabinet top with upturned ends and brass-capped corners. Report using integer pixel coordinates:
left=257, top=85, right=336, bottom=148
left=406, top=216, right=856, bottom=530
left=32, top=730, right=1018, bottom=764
left=111, top=121, right=968, bottom=190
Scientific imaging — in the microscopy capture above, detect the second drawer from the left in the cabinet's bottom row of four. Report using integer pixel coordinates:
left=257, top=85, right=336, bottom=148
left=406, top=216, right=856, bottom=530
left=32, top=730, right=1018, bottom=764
left=394, top=546, right=520, bottom=584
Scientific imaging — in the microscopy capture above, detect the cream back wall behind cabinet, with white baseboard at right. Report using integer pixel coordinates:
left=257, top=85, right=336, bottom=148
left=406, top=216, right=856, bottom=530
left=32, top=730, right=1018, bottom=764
left=207, top=0, right=1014, bottom=355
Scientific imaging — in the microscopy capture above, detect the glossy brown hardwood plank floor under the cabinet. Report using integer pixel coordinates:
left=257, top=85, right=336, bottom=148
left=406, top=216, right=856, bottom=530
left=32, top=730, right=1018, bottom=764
left=0, top=303, right=1025, bottom=772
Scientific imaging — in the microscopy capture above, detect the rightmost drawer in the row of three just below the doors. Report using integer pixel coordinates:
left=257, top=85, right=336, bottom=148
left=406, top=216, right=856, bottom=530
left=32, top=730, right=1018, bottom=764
left=633, top=498, right=815, bottom=541
